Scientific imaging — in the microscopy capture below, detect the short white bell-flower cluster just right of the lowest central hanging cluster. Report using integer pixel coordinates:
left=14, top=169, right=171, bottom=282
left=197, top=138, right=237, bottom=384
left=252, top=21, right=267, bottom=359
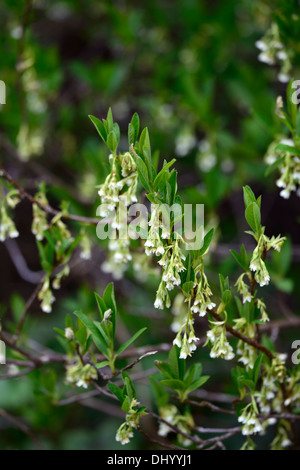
left=204, top=321, right=235, bottom=361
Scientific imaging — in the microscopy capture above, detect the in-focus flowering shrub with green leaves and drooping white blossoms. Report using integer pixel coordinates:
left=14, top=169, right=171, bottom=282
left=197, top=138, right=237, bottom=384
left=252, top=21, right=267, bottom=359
left=1, top=104, right=300, bottom=448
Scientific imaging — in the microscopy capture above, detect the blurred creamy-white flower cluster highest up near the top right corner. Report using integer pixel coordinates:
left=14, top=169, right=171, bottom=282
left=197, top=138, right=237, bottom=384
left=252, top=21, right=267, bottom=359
left=255, top=23, right=292, bottom=83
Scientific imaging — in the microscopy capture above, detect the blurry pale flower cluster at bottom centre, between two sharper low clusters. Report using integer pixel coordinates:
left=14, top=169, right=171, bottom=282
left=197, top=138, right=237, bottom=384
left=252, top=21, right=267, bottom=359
left=158, top=405, right=195, bottom=447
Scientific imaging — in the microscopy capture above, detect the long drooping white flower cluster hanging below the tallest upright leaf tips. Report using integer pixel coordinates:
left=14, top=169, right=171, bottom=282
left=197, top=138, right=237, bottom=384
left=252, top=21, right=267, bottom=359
left=99, top=152, right=138, bottom=279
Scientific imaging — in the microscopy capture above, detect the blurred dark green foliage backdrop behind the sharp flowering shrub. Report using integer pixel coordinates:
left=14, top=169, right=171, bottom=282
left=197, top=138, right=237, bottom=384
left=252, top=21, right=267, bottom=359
left=0, top=0, right=300, bottom=449
